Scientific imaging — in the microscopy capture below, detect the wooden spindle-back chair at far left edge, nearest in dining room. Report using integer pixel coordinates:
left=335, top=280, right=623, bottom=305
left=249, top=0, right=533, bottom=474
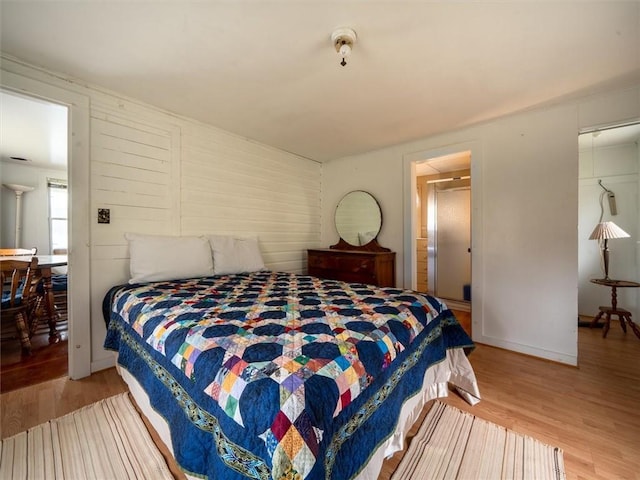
left=0, top=256, right=39, bottom=355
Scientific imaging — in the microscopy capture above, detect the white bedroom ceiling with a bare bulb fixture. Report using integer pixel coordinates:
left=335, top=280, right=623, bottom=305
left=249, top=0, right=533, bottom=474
left=0, top=0, right=640, bottom=161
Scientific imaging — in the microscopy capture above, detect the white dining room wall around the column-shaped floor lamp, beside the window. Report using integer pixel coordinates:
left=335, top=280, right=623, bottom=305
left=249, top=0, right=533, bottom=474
left=0, top=162, right=67, bottom=251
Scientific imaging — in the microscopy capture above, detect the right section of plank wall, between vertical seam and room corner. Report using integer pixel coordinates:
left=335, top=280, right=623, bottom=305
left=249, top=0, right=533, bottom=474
left=181, top=125, right=321, bottom=273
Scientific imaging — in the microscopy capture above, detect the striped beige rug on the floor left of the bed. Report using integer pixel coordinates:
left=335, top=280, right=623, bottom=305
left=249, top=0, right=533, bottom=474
left=0, top=393, right=173, bottom=480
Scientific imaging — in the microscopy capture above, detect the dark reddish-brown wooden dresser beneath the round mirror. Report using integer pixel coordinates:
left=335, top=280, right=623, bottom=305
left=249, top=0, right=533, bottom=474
left=307, top=248, right=396, bottom=287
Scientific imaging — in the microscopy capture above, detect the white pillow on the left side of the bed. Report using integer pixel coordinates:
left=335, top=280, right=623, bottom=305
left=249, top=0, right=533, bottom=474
left=124, top=233, right=213, bottom=283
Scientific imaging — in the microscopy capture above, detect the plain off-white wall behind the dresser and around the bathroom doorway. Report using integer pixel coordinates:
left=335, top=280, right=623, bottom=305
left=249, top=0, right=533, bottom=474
left=322, top=87, right=640, bottom=365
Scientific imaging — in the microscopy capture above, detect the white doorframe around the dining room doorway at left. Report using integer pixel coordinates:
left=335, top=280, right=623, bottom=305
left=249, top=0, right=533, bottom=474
left=0, top=69, right=91, bottom=380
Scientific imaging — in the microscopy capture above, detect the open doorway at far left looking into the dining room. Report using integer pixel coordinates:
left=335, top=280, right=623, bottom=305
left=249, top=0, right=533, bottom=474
left=0, top=90, right=69, bottom=392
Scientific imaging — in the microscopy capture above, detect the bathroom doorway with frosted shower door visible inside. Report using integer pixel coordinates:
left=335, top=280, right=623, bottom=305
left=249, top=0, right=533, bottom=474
left=405, top=150, right=470, bottom=338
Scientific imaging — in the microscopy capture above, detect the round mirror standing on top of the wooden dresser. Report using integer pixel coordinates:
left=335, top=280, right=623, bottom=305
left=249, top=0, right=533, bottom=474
left=335, top=190, right=382, bottom=247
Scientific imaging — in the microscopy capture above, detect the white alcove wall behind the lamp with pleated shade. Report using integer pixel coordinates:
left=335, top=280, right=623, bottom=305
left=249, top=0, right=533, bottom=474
left=578, top=140, right=640, bottom=319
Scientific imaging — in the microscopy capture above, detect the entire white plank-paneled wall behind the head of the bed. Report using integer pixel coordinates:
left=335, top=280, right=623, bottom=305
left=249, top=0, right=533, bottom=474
left=0, top=54, right=321, bottom=371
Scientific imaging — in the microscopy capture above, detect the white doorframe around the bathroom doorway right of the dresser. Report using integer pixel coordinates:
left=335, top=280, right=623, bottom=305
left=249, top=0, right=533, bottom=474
left=403, top=140, right=484, bottom=339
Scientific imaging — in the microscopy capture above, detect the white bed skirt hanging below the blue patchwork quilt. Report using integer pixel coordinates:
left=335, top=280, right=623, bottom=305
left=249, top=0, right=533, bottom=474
left=116, top=348, right=480, bottom=480
